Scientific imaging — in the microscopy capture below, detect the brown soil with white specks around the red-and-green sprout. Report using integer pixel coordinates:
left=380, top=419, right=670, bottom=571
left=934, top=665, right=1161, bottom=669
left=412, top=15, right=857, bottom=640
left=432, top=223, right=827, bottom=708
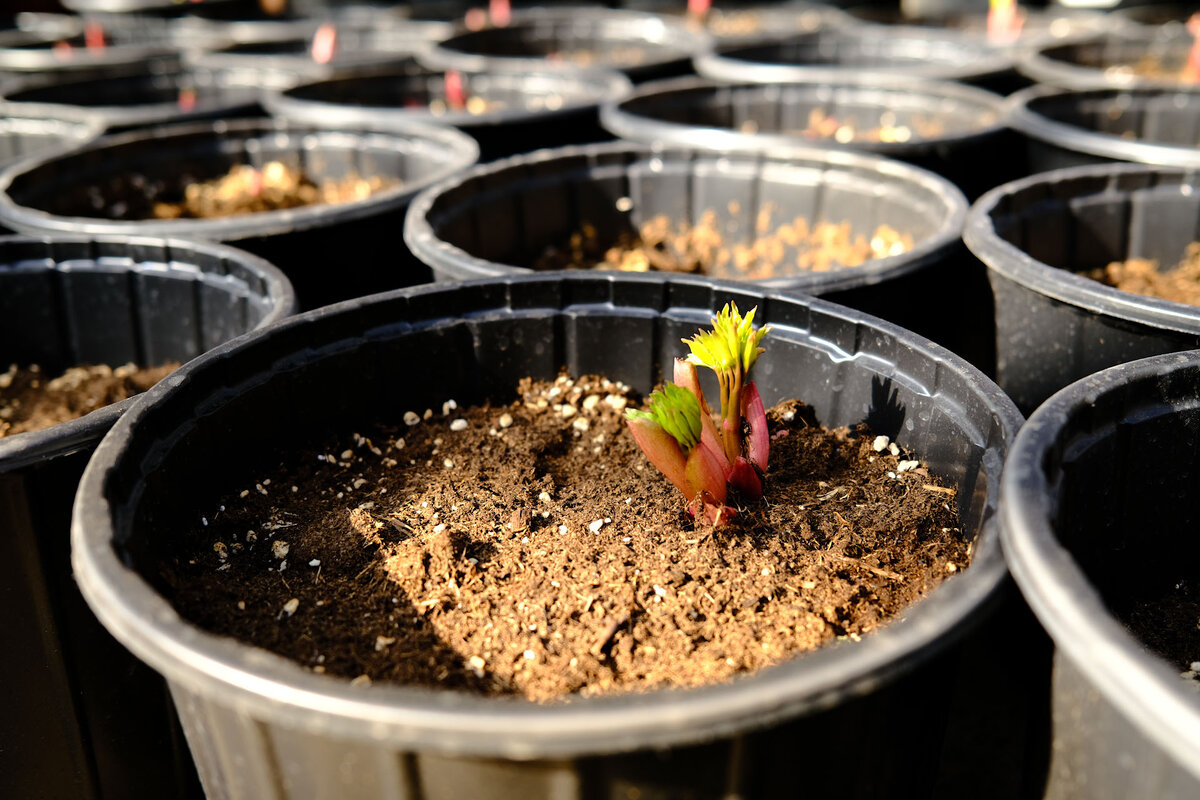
left=149, top=375, right=971, bottom=702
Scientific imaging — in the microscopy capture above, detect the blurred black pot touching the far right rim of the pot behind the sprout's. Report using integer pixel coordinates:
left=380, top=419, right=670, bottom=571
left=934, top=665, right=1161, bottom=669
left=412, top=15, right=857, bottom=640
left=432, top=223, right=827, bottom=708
left=600, top=77, right=1021, bottom=197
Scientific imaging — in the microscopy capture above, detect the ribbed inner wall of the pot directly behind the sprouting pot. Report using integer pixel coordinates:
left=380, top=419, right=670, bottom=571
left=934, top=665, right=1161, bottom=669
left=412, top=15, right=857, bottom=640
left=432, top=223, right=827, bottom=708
left=428, top=151, right=946, bottom=277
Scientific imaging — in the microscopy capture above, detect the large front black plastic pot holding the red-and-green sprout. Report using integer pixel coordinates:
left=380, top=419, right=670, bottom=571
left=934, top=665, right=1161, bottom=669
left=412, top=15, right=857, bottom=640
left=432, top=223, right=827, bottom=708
left=65, top=273, right=1020, bottom=800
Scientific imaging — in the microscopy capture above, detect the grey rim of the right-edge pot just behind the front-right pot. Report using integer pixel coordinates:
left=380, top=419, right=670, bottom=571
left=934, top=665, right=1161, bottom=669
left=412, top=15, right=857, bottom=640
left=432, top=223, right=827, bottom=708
left=962, top=163, right=1200, bottom=333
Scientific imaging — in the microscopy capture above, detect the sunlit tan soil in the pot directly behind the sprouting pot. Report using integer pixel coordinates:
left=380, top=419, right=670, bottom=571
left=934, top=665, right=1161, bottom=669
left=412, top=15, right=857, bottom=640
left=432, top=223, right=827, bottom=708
left=534, top=208, right=913, bottom=279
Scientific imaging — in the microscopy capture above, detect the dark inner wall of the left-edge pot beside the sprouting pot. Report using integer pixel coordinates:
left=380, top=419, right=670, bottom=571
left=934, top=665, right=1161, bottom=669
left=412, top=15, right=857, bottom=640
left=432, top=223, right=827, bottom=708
left=0, top=241, right=277, bottom=375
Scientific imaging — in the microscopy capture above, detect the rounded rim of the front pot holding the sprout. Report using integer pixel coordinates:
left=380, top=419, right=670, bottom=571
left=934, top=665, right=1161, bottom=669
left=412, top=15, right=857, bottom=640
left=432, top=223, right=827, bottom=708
left=72, top=273, right=1021, bottom=760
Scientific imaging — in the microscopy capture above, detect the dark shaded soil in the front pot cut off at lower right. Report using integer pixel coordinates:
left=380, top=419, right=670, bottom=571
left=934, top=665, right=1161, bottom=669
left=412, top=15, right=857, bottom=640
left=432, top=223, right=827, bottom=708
left=1117, top=578, right=1200, bottom=690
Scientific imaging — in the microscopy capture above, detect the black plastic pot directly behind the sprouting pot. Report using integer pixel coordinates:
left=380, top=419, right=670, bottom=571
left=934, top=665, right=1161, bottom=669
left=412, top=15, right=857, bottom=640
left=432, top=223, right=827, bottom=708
left=404, top=143, right=991, bottom=368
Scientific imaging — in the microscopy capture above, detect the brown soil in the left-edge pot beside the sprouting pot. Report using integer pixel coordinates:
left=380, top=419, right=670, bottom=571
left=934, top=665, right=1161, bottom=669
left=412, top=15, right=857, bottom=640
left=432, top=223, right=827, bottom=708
left=0, top=363, right=179, bottom=438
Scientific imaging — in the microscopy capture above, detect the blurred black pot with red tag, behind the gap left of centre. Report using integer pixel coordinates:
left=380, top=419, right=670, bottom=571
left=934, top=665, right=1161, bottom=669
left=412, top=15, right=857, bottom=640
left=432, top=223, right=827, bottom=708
left=265, top=66, right=632, bottom=161
